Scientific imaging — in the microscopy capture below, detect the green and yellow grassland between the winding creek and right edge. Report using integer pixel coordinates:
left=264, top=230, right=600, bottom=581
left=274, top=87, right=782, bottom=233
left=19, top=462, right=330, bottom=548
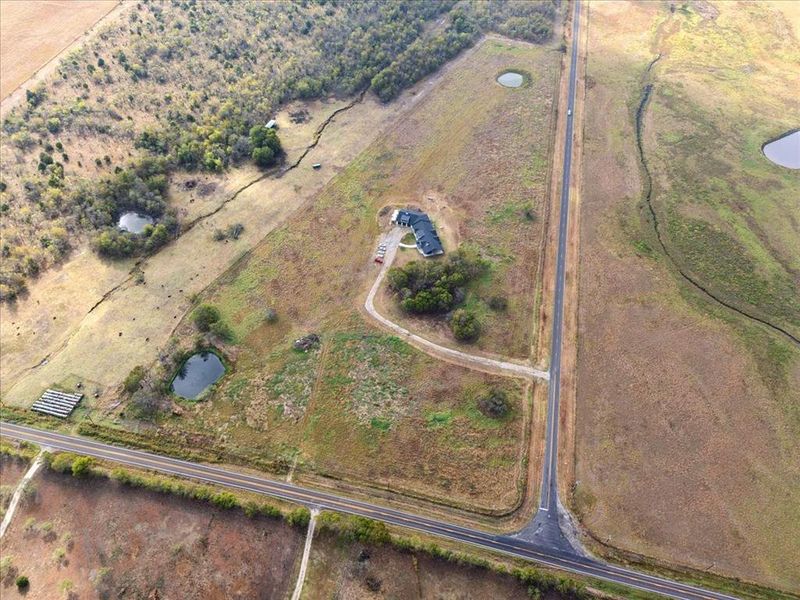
left=644, top=6, right=800, bottom=338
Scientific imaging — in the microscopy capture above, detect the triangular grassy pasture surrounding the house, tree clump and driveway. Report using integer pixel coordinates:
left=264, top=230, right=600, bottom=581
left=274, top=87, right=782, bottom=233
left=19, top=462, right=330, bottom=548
left=156, top=39, right=558, bottom=513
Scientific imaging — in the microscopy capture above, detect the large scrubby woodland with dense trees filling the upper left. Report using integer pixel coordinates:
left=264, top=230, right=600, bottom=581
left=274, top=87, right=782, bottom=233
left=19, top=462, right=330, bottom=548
left=0, top=0, right=556, bottom=299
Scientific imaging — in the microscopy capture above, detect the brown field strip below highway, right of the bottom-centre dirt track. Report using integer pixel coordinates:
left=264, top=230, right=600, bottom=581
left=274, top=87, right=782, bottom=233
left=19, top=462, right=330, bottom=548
left=301, top=531, right=544, bottom=600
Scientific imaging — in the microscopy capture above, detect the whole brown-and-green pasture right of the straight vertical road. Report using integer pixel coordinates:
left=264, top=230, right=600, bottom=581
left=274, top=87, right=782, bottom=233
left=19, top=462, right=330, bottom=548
left=572, top=2, right=800, bottom=591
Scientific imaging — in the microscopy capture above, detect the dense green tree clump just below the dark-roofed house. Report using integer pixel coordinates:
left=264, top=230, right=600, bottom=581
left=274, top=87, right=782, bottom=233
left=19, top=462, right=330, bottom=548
left=387, top=248, right=489, bottom=342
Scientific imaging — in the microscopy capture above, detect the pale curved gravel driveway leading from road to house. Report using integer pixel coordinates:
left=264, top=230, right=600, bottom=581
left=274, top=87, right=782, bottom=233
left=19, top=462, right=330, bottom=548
left=364, top=227, right=550, bottom=381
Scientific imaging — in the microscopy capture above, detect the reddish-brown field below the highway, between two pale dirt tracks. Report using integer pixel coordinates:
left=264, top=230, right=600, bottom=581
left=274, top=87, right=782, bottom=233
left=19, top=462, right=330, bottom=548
left=0, top=470, right=304, bottom=600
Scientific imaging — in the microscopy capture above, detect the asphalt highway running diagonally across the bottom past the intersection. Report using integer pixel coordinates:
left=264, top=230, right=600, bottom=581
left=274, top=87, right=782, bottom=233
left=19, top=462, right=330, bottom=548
left=0, top=422, right=733, bottom=600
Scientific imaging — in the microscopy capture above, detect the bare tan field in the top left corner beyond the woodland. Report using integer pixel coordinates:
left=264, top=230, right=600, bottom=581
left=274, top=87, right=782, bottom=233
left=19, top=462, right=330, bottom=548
left=0, top=0, right=120, bottom=100
